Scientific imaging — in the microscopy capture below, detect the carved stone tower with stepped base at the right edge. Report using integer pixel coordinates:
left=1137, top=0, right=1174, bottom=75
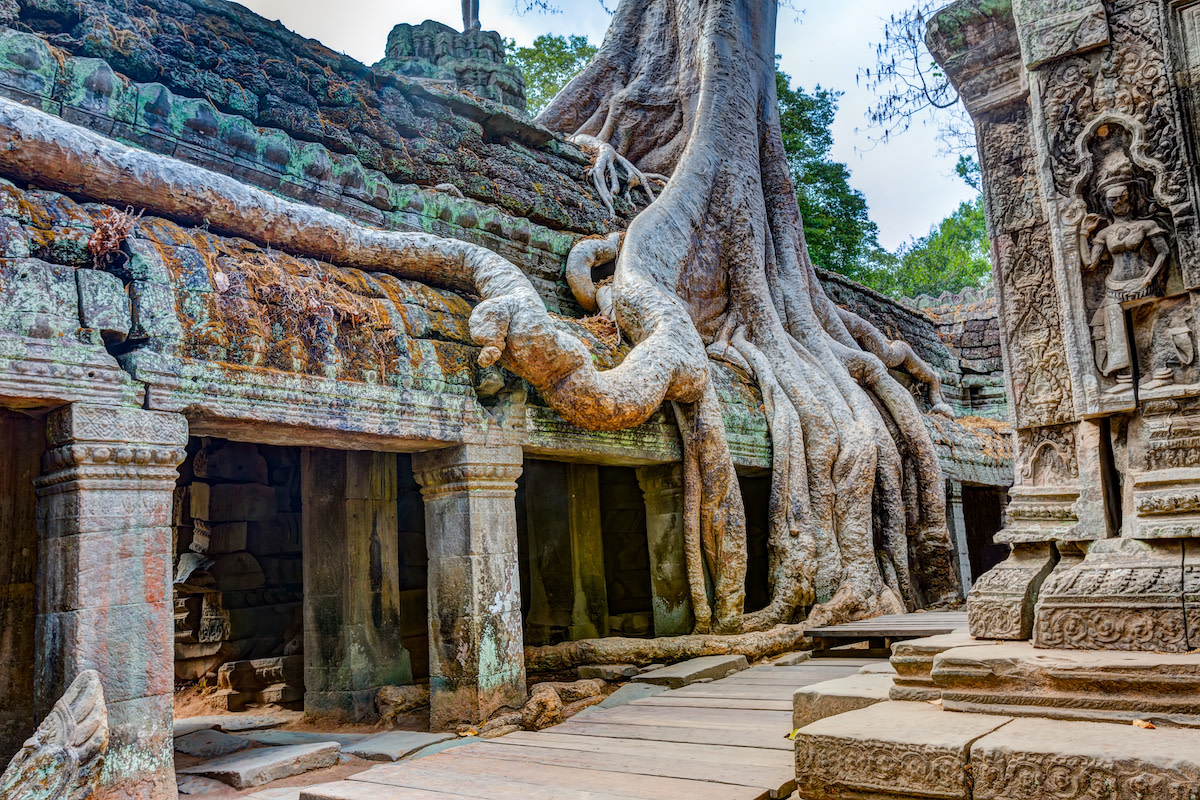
left=797, top=0, right=1200, bottom=800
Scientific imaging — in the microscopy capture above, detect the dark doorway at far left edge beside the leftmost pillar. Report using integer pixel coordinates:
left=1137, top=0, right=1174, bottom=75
left=0, top=409, right=46, bottom=764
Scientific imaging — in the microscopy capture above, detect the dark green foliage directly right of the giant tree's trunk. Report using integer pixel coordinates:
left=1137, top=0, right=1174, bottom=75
left=775, top=72, right=894, bottom=285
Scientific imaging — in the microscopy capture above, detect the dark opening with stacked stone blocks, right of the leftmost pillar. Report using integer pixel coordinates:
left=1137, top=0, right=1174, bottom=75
left=173, top=437, right=304, bottom=711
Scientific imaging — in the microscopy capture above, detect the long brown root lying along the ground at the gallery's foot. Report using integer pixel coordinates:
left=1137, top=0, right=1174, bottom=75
left=526, top=625, right=809, bottom=672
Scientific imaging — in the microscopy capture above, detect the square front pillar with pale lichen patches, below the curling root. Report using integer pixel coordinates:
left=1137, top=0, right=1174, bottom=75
left=413, top=445, right=526, bottom=730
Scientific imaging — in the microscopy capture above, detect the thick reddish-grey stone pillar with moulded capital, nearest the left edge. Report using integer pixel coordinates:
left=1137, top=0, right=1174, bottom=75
left=35, top=404, right=187, bottom=800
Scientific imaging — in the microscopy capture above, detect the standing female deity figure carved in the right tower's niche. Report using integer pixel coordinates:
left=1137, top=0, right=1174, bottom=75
left=1085, top=182, right=1171, bottom=392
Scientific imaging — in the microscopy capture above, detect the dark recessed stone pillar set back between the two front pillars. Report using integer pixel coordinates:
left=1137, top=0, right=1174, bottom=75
left=300, top=447, right=413, bottom=722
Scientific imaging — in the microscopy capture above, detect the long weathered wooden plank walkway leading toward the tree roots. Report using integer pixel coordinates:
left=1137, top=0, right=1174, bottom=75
left=300, top=658, right=875, bottom=800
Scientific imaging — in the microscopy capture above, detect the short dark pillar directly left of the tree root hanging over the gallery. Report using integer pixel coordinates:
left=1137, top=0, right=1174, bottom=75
left=637, top=464, right=695, bottom=636
